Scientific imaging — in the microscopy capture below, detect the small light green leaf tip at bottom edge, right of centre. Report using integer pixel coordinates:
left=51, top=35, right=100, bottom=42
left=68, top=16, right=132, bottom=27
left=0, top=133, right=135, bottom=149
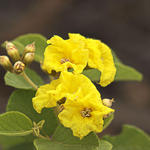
left=97, top=140, right=112, bottom=150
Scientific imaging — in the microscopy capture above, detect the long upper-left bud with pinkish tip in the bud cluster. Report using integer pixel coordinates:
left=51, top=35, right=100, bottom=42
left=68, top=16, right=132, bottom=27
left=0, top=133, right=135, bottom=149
left=5, top=41, right=20, bottom=62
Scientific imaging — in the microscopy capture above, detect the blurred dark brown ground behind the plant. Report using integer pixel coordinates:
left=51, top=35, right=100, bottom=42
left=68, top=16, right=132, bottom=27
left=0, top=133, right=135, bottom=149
left=0, top=0, right=150, bottom=137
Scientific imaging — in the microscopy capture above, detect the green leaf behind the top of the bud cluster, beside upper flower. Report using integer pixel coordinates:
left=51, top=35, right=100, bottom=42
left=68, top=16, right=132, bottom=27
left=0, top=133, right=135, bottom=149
left=12, top=33, right=47, bottom=62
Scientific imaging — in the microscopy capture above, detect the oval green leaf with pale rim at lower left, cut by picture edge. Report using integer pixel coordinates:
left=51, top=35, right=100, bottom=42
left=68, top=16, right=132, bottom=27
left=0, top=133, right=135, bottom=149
left=0, top=111, right=32, bottom=136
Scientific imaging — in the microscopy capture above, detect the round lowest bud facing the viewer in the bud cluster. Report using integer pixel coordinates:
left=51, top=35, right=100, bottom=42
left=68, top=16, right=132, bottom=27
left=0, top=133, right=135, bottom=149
left=14, top=61, right=25, bottom=74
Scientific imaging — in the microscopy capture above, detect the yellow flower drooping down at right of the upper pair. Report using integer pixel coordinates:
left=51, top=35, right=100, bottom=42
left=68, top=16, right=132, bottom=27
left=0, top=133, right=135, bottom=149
left=69, top=34, right=116, bottom=87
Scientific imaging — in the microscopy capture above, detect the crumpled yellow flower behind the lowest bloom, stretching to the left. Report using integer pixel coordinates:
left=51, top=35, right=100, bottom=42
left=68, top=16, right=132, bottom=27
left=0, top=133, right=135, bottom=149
left=32, top=72, right=102, bottom=113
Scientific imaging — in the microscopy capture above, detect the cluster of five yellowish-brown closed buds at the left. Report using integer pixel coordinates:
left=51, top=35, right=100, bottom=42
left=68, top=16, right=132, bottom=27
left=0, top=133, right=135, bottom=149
left=0, top=41, right=35, bottom=74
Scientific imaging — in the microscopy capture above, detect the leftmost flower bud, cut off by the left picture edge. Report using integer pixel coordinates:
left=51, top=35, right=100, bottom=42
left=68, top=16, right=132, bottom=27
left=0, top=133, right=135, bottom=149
left=0, top=56, right=13, bottom=72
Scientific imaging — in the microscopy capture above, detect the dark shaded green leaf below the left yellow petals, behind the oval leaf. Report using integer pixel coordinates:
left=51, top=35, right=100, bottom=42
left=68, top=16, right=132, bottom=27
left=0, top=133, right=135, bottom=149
left=7, top=89, right=57, bottom=136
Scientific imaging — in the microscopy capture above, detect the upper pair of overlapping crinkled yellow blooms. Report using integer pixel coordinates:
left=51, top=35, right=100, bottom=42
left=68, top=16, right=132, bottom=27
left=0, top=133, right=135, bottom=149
left=43, top=33, right=116, bottom=86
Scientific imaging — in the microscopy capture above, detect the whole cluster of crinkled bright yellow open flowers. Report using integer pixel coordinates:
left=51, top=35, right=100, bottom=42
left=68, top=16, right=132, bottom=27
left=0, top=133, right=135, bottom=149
left=32, top=34, right=116, bottom=139
